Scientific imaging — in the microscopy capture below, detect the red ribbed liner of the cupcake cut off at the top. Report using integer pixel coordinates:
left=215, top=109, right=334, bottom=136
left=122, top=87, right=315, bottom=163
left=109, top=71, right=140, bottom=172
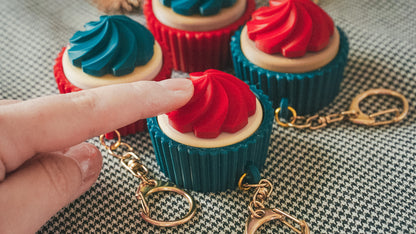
left=143, top=0, right=256, bottom=72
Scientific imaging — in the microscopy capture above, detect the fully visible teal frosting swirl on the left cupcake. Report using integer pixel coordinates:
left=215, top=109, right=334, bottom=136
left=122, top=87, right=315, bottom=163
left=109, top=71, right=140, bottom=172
left=68, top=15, right=155, bottom=76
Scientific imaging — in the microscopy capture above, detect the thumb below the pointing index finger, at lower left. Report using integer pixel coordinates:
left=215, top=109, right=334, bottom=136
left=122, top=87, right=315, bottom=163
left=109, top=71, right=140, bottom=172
left=0, top=143, right=102, bottom=233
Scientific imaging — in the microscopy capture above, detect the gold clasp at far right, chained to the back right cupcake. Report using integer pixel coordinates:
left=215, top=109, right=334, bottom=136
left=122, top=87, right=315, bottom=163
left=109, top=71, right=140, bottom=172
left=349, top=89, right=409, bottom=126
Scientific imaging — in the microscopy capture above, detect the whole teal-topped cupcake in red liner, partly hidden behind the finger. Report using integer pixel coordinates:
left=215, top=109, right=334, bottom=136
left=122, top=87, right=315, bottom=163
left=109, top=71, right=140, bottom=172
left=54, top=15, right=172, bottom=138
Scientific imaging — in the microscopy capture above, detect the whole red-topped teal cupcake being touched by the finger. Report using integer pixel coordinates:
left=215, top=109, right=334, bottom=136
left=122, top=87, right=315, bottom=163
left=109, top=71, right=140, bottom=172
left=147, top=69, right=273, bottom=192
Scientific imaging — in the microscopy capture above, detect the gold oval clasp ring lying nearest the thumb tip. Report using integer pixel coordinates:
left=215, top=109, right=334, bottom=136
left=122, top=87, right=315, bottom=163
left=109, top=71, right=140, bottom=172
left=136, top=180, right=196, bottom=227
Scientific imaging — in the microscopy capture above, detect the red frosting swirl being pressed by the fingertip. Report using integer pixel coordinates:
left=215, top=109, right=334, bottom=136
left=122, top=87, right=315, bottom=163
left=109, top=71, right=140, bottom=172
left=167, top=69, right=256, bottom=138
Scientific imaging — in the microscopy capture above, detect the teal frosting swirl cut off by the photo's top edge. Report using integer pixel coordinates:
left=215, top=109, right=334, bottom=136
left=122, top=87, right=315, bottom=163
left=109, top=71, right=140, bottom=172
left=160, top=0, right=236, bottom=16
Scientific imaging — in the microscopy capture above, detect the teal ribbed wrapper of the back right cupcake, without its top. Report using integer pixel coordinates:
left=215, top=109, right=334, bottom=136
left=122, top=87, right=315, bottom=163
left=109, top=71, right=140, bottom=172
left=231, top=28, right=349, bottom=115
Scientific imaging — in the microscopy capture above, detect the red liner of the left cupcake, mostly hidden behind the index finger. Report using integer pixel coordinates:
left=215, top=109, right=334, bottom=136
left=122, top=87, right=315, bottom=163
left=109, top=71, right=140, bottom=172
left=53, top=43, right=172, bottom=139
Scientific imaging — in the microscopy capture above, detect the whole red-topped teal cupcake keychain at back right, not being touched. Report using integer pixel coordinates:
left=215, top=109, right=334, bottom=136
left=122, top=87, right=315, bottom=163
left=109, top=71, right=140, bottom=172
left=231, top=0, right=349, bottom=115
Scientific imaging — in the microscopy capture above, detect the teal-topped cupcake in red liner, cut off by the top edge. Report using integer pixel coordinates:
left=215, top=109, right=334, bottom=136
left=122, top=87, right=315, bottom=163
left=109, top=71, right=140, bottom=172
left=143, top=0, right=255, bottom=72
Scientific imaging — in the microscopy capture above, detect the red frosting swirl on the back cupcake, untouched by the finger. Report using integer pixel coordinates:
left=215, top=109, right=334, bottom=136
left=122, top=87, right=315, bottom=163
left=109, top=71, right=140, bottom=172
left=247, top=0, right=334, bottom=58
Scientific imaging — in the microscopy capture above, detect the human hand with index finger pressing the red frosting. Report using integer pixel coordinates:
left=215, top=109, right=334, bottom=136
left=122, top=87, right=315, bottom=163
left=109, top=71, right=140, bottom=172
left=0, top=79, right=193, bottom=233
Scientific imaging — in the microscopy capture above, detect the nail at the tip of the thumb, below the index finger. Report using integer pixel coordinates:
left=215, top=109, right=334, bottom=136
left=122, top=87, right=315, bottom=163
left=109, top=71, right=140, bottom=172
left=65, top=142, right=102, bottom=184
